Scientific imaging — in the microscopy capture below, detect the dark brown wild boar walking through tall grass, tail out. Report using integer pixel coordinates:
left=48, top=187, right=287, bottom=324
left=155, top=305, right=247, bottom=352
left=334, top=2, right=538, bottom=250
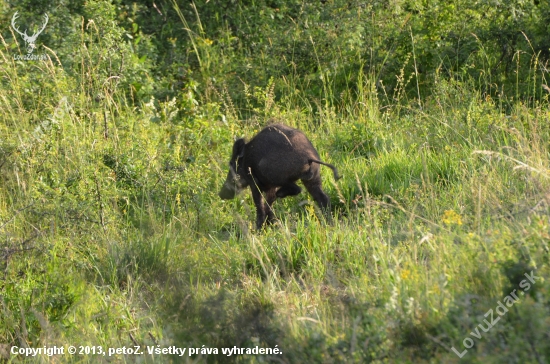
left=219, top=124, right=340, bottom=229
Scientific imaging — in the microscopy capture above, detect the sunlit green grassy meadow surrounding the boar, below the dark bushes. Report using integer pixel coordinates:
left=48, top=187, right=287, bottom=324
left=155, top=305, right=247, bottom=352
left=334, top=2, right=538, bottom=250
left=0, top=4, right=550, bottom=363
